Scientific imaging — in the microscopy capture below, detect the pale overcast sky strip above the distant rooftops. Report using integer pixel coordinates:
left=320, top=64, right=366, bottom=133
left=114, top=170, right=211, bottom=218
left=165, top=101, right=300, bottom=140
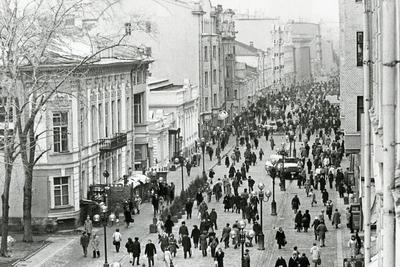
left=211, top=0, right=339, bottom=22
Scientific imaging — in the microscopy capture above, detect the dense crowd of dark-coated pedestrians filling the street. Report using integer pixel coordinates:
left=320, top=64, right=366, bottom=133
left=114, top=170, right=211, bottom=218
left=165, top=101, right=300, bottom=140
left=77, top=79, right=362, bottom=267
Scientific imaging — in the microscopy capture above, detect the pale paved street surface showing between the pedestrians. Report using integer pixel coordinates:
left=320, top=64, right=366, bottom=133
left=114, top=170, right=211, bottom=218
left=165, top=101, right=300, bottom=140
left=18, top=136, right=354, bottom=267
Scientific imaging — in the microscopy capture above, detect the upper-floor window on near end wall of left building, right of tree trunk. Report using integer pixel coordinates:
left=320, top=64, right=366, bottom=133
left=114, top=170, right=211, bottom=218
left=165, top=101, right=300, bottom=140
left=53, top=112, right=68, bottom=152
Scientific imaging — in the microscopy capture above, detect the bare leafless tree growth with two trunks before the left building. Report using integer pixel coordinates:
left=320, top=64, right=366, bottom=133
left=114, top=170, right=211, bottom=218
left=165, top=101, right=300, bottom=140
left=0, top=0, right=152, bottom=248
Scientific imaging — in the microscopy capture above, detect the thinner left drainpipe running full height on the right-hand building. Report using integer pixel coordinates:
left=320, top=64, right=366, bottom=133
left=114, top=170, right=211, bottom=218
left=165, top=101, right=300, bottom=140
left=363, top=0, right=371, bottom=265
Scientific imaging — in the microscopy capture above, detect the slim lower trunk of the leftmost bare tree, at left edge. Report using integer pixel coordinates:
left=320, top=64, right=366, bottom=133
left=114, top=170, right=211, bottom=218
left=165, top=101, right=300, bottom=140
left=0, top=161, right=13, bottom=257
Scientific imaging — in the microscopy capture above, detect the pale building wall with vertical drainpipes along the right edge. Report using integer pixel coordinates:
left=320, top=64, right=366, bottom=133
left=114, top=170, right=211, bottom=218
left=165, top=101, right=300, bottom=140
left=340, top=0, right=400, bottom=267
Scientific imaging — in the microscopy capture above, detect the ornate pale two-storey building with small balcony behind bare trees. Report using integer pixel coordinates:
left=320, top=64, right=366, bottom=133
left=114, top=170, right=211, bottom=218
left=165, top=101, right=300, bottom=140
left=1, top=55, right=151, bottom=225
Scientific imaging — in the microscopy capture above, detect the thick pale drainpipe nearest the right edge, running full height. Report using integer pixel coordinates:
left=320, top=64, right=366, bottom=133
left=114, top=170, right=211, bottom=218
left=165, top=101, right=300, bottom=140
left=382, top=0, right=397, bottom=266
